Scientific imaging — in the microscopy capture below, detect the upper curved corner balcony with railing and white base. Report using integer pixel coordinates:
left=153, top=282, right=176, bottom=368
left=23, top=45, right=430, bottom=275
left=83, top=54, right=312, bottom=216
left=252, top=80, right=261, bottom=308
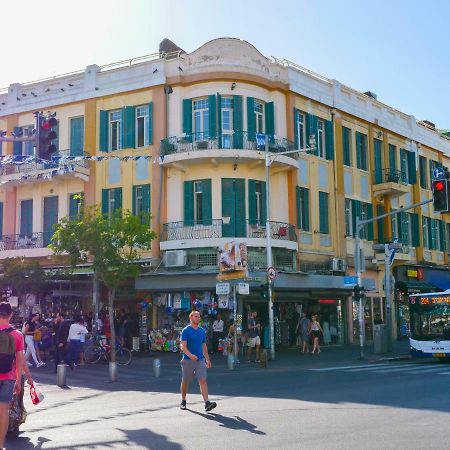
left=160, top=131, right=298, bottom=165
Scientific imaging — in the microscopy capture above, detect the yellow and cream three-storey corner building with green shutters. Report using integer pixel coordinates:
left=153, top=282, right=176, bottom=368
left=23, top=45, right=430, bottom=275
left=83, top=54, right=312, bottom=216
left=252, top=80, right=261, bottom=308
left=0, top=38, right=450, bottom=344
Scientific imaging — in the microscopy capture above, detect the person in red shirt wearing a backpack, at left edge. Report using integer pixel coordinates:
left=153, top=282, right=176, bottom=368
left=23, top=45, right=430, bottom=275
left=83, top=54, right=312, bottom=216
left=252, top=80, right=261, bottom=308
left=0, top=302, right=34, bottom=448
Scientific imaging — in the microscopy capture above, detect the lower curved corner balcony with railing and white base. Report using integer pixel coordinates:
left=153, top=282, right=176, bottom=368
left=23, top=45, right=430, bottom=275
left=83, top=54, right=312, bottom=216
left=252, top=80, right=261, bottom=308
left=161, top=218, right=297, bottom=250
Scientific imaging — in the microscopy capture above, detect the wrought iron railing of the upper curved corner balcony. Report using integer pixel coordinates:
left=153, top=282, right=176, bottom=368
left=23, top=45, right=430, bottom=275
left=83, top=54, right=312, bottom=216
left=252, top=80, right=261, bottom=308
left=161, top=131, right=298, bottom=159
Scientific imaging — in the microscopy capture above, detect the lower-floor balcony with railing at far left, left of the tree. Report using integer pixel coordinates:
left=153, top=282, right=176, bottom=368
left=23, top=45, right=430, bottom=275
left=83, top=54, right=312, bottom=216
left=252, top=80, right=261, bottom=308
left=0, top=232, right=53, bottom=259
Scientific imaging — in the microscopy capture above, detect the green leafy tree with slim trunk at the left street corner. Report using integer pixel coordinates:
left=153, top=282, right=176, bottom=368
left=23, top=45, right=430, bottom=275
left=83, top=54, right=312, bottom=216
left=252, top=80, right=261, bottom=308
left=50, top=205, right=155, bottom=362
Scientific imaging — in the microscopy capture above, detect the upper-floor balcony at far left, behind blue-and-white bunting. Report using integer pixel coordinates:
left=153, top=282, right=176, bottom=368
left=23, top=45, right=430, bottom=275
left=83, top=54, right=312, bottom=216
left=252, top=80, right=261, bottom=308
left=0, top=150, right=89, bottom=183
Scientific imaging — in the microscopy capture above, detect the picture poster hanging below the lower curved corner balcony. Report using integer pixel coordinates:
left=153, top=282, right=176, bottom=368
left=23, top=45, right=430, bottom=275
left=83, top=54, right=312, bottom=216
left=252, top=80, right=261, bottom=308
left=217, top=241, right=248, bottom=281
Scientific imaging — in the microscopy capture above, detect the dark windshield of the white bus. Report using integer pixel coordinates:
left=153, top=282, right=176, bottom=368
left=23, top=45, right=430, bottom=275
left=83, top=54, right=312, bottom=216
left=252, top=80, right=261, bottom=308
left=410, top=299, right=450, bottom=341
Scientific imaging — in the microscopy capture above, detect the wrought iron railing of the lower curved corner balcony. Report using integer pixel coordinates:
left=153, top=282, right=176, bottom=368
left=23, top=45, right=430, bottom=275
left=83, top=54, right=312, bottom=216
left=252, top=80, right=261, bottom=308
left=161, top=218, right=297, bottom=242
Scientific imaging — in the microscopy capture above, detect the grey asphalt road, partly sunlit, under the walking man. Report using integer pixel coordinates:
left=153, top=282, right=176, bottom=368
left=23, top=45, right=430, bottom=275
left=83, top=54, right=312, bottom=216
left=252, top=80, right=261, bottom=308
left=6, top=349, right=450, bottom=450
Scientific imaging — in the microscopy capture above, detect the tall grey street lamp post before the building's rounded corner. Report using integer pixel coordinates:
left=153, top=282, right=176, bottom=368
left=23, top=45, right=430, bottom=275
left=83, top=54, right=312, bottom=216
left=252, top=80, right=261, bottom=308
left=264, top=134, right=316, bottom=360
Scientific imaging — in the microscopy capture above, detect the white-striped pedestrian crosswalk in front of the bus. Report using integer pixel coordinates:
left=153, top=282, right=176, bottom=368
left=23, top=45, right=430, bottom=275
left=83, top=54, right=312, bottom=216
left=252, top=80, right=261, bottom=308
left=309, top=361, right=450, bottom=375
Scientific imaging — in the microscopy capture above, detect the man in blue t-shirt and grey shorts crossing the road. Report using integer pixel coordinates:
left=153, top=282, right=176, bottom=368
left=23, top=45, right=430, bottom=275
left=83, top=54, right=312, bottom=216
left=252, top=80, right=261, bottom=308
left=180, top=311, right=217, bottom=411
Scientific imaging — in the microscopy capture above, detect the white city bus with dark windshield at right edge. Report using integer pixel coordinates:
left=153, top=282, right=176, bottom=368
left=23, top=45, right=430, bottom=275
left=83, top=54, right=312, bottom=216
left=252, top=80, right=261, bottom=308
left=409, top=289, right=450, bottom=360
